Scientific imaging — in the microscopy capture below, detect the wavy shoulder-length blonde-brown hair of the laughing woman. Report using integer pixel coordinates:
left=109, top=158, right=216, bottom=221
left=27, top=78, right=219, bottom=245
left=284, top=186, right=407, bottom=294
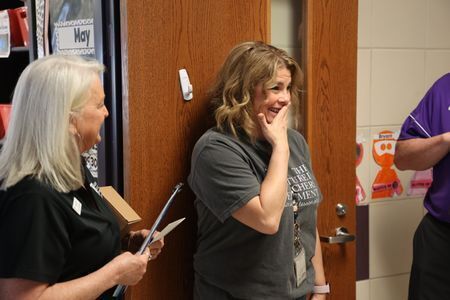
left=210, top=42, right=303, bottom=142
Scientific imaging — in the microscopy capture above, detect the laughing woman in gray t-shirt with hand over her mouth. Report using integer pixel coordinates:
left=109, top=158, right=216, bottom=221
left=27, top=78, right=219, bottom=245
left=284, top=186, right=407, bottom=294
left=188, top=42, right=329, bottom=300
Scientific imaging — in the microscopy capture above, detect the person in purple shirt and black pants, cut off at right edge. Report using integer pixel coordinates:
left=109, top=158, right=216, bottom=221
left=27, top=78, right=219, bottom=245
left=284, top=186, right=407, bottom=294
left=395, top=73, right=450, bottom=300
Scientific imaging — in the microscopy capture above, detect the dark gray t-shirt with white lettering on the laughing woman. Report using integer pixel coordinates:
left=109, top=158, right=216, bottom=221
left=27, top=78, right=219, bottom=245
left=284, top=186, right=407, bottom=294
left=188, top=129, right=321, bottom=300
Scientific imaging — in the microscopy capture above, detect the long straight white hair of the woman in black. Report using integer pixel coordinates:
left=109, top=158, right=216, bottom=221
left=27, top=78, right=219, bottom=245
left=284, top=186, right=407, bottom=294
left=0, top=55, right=104, bottom=192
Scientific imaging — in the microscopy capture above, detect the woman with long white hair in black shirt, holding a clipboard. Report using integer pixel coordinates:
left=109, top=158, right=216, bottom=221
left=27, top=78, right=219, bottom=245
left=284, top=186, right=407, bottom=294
left=0, top=55, right=163, bottom=300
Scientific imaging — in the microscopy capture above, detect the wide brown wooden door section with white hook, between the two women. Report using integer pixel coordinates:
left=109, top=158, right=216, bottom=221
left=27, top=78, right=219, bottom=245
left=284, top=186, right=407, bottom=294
left=121, top=0, right=269, bottom=300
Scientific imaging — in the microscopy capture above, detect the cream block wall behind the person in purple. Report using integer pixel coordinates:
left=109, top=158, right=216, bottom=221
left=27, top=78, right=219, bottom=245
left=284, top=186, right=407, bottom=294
left=356, top=0, right=450, bottom=300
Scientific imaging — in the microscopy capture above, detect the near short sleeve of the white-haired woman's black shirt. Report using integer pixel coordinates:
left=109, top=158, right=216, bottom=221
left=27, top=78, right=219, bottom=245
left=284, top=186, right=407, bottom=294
left=0, top=183, right=71, bottom=284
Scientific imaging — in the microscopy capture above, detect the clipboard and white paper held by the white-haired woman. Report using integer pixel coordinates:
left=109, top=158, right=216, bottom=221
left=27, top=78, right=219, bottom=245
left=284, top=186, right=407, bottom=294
left=113, top=182, right=184, bottom=298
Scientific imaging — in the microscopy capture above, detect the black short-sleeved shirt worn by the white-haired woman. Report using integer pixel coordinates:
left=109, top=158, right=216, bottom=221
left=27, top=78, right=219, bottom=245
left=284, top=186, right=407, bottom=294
left=0, top=169, right=120, bottom=296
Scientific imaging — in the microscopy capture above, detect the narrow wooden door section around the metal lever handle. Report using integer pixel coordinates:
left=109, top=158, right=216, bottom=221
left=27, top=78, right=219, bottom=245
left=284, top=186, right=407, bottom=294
left=304, top=0, right=358, bottom=300
